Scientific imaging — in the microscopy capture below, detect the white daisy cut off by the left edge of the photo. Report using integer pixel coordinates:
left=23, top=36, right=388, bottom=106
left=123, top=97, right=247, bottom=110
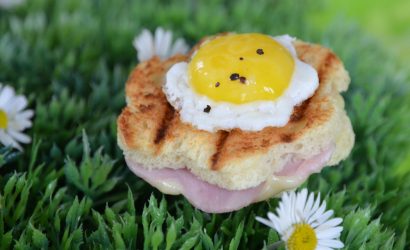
left=0, top=84, right=34, bottom=150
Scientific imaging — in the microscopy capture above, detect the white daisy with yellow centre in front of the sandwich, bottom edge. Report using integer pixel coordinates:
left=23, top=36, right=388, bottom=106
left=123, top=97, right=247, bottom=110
left=256, top=188, right=344, bottom=250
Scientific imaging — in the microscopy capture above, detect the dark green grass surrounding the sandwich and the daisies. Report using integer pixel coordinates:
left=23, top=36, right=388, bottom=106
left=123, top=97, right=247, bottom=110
left=0, top=0, right=410, bottom=249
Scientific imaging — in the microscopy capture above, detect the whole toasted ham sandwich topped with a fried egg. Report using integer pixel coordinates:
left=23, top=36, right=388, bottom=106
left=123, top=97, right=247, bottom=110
left=117, top=33, right=354, bottom=213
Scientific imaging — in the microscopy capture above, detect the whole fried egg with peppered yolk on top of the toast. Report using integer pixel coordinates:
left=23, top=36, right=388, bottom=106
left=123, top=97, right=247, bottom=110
left=163, top=33, right=319, bottom=132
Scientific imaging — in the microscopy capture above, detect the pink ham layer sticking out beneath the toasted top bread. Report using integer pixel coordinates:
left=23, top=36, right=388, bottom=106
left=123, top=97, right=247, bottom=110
left=126, top=146, right=334, bottom=213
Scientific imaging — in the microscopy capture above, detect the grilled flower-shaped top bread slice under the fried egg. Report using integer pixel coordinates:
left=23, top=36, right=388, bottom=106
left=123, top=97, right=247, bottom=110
left=117, top=41, right=354, bottom=190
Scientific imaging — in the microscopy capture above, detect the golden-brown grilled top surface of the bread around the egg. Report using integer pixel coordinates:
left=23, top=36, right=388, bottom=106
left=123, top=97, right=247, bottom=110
left=118, top=41, right=352, bottom=186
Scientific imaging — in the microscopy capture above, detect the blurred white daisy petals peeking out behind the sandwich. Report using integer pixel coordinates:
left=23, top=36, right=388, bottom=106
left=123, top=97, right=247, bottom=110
left=133, top=27, right=189, bottom=62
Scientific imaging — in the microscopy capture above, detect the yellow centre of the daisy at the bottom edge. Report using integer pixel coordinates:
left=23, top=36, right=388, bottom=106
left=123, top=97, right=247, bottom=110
left=286, top=223, right=317, bottom=250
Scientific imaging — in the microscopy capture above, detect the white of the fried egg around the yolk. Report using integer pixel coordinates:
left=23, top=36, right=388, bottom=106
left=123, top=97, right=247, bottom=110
left=163, top=35, right=319, bottom=132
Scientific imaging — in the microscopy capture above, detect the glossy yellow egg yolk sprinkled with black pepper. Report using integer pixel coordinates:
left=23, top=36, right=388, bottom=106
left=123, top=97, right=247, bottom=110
left=188, top=33, right=295, bottom=104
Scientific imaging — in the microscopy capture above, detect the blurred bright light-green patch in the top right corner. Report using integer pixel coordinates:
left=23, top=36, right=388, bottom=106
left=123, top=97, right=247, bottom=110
left=310, top=0, right=410, bottom=66
